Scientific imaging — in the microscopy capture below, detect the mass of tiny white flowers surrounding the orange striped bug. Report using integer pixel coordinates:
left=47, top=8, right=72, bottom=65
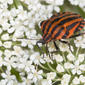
left=0, top=0, right=85, bottom=85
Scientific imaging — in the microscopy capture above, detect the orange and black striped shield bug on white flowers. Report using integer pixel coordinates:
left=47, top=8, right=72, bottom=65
left=36, top=12, right=85, bottom=54
